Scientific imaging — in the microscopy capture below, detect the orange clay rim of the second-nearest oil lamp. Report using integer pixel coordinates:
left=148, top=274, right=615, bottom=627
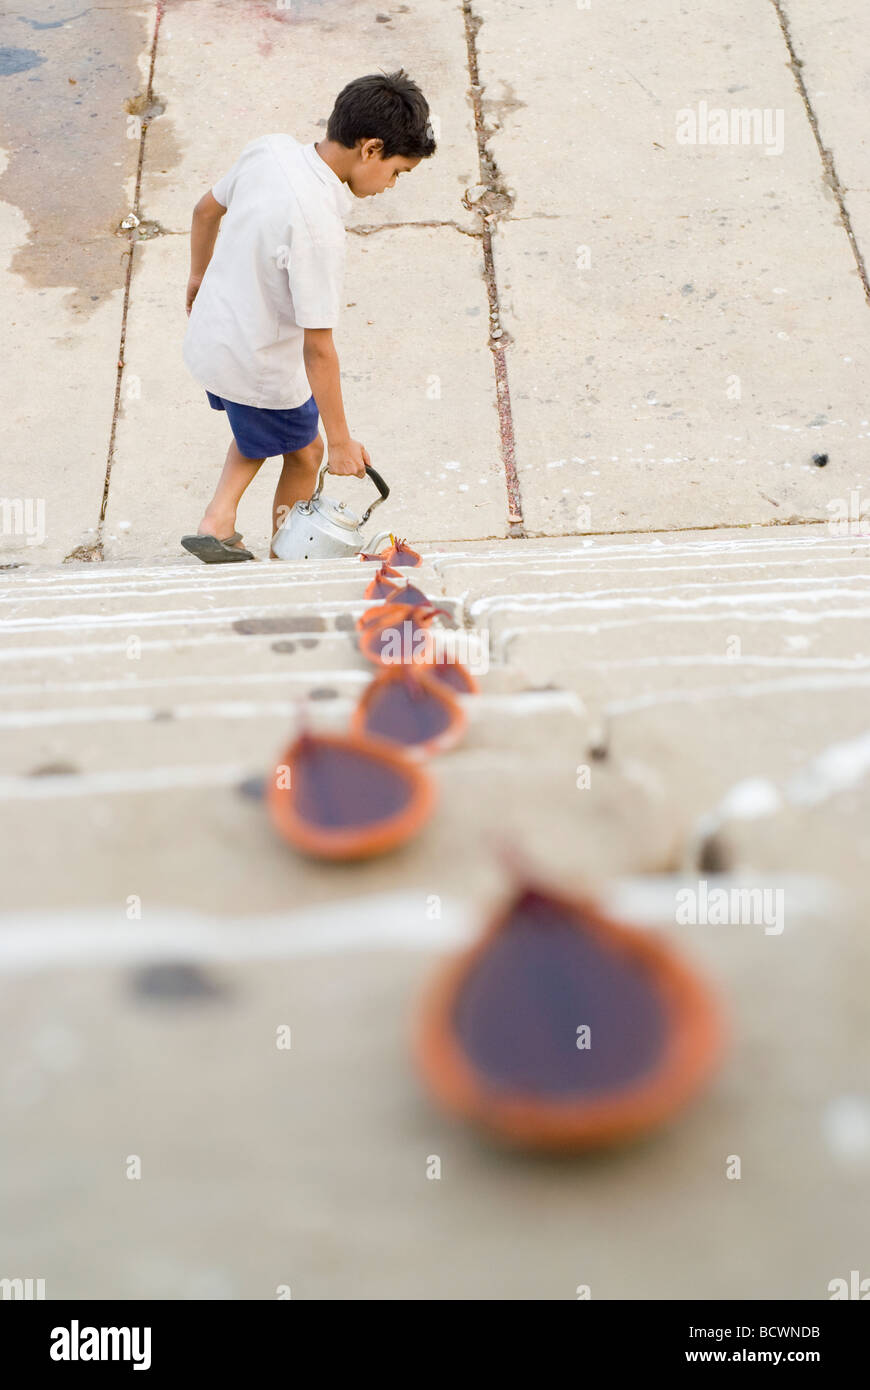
left=267, top=734, right=436, bottom=859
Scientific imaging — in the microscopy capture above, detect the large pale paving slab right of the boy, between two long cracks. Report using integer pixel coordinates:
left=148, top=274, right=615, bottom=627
left=475, top=0, right=870, bottom=534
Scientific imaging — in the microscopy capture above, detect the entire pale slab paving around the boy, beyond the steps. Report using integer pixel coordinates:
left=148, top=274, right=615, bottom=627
left=0, top=0, right=870, bottom=564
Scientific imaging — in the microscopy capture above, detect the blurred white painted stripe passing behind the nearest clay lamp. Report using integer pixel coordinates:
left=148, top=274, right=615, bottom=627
left=0, top=873, right=841, bottom=974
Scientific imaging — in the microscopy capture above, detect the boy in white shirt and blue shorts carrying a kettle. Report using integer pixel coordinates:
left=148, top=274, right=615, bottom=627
left=181, top=68, right=435, bottom=564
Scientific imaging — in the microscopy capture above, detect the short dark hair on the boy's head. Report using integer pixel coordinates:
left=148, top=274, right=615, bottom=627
left=327, top=68, right=435, bottom=160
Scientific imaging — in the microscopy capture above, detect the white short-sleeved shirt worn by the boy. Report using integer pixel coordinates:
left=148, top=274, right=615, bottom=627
left=183, top=135, right=353, bottom=410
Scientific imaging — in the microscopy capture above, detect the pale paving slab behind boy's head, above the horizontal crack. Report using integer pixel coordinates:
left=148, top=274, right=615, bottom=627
left=143, top=0, right=478, bottom=237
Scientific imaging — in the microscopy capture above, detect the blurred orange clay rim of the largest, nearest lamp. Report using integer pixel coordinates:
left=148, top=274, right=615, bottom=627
left=414, top=883, right=725, bottom=1151
